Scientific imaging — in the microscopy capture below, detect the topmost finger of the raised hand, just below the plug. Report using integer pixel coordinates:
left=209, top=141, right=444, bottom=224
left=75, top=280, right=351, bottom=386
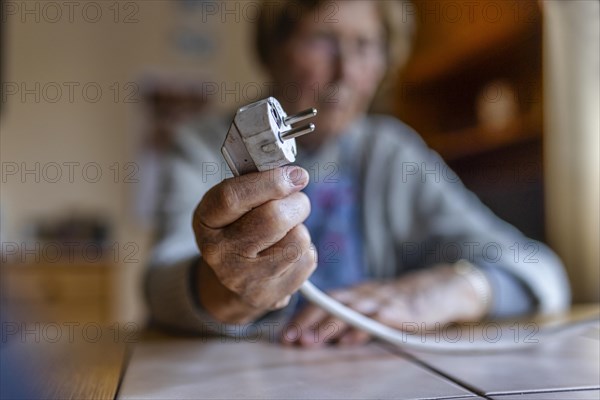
left=195, top=166, right=308, bottom=229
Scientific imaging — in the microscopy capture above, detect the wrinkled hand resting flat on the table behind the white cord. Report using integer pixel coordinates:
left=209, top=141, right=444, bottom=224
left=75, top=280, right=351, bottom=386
left=282, top=265, right=486, bottom=347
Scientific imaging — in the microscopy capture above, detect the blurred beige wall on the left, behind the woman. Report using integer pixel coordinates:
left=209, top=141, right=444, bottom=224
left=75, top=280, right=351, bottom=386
left=0, top=1, right=258, bottom=318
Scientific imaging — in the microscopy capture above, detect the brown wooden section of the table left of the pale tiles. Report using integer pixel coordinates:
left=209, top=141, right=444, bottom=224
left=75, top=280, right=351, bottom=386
left=0, top=321, right=130, bottom=400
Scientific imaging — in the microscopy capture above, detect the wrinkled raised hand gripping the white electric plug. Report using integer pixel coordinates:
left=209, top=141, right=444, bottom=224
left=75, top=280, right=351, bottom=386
left=193, top=167, right=316, bottom=323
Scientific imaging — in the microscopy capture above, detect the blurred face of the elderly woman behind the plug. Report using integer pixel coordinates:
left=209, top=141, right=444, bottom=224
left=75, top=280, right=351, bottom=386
left=271, top=1, right=386, bottom=145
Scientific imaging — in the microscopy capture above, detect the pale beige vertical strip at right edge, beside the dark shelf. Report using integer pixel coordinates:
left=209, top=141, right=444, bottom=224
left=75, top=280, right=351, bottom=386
left=544, top=1, right=600, bottom=302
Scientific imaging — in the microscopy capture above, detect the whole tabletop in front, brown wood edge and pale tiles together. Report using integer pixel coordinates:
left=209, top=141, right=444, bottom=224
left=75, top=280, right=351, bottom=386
left=1, top=305, right=600, bottom=400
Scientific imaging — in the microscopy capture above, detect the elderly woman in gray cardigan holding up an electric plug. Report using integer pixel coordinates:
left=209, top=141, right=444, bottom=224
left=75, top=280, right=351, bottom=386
left=146, top=0, right=569, bottom=345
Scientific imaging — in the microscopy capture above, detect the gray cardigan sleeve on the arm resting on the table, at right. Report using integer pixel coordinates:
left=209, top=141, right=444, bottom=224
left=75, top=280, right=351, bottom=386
left=367, top=117, right=570, bottom=316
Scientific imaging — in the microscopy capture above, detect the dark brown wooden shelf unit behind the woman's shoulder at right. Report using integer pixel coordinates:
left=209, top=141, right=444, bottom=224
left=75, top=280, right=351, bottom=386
left=396, top=0, right=544, bottom=239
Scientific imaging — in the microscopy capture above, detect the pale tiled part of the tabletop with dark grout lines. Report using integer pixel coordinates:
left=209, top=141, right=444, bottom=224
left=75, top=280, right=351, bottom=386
left=118, top=306, right=600, bottom=400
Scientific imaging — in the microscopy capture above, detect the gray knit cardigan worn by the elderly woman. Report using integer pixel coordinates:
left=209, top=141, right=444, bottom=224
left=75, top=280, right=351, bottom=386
left=145, top=115, right=570, bottom=335
